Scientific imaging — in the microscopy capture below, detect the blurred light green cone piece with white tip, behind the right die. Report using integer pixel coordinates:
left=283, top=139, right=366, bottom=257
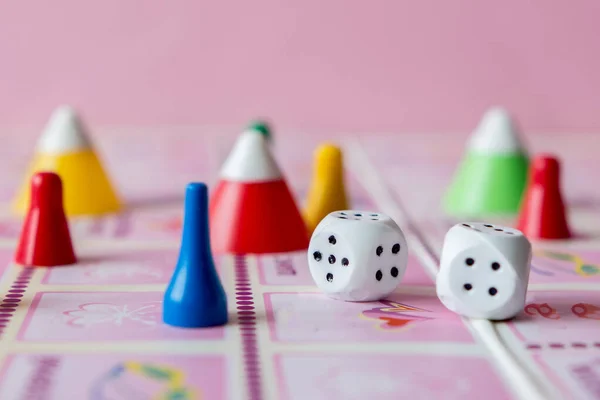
left=444, top=108, right=529, bottom=218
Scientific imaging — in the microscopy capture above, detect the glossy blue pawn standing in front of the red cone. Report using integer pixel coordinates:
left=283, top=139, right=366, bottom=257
left=163, top=183, right=227, bottom=328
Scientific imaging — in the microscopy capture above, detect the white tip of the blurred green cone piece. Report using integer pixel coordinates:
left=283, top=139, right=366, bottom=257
left=468, top=107, right=524, bottom=154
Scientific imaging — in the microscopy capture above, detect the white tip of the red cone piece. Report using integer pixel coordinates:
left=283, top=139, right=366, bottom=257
left=221, top=131, right=282, bottom=182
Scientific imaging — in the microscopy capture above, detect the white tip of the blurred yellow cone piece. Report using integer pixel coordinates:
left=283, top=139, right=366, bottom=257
left=37, top=106, right=91, bottom=153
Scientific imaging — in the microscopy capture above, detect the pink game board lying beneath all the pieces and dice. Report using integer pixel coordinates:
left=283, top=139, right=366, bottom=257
left=0, top=127, right=600, bottom=400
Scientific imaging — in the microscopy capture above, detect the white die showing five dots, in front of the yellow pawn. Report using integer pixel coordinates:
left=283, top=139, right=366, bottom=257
left=308, top=210, right=408, bottom=301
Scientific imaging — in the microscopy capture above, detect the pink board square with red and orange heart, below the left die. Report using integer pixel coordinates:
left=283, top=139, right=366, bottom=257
left=264, top=293, right=473, bottom=343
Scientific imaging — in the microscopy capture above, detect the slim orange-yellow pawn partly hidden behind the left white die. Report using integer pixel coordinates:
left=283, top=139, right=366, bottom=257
left=304, top=144, right=350, bottom=234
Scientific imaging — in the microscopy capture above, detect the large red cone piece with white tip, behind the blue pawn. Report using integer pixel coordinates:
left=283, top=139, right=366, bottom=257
left=210, top=131, right=309, bottom=254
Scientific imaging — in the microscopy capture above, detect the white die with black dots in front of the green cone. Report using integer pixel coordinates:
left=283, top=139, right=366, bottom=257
left=436, top=223, right=531, bottom=320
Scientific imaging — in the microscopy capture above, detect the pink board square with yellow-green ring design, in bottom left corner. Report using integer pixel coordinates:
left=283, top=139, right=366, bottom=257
left=0, top=354, right=228, bottom=400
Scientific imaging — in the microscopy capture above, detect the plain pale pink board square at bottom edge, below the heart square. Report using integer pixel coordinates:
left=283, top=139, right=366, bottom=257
left=275, top=354, right=511, bottom=400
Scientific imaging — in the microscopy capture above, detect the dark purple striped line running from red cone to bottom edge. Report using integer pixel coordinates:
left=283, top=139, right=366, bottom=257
left=235, top=256, right=263, bottom=400
